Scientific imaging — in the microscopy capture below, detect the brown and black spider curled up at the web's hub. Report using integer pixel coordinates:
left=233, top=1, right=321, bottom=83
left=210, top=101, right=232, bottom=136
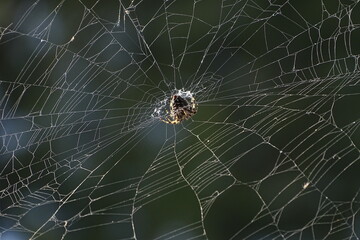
left=160, top=94, right=197, bottom=124
